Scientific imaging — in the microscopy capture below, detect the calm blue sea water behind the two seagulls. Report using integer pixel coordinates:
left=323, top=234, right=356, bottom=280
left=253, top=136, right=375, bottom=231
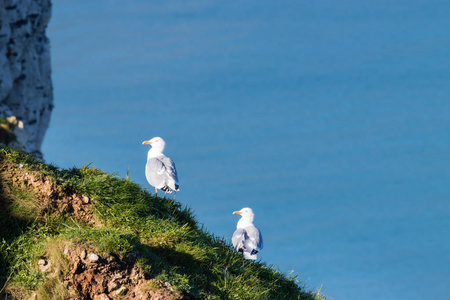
left=43, top=0, right=450, bottom=300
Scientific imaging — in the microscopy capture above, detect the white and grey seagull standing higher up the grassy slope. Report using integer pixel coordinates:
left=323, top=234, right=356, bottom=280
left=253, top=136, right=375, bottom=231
left=142, top=137, right=179, bottom=198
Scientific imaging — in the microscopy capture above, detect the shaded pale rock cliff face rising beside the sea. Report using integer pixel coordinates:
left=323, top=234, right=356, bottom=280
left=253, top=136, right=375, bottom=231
left=0, top=0, right=53, bottom=157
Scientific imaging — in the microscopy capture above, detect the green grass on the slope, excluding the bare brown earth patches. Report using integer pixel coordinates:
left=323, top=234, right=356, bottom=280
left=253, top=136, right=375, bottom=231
left=0, top=148, right=323, bottom=299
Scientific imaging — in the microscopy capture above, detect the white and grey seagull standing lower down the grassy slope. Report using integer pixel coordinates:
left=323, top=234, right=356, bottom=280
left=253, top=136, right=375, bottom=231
left=231, top=207, right=263, bottom=260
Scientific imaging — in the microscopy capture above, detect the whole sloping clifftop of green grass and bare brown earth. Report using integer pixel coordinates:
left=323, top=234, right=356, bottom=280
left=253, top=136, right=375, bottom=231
left=0, top=146, right=326, bottom=300
